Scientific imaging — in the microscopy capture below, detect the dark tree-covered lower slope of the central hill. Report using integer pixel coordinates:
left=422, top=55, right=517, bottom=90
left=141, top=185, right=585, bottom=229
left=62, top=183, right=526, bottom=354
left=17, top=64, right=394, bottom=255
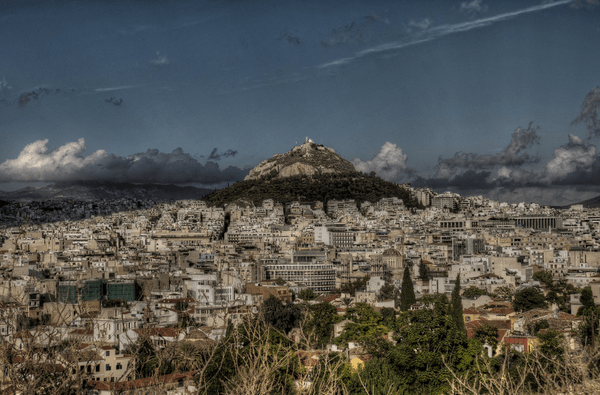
left=203, top=171, right=419, bottom=207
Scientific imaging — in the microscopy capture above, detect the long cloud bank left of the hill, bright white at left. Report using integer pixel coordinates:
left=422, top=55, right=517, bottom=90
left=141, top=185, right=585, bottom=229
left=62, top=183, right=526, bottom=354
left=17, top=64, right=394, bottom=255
left=0, top=139, right=249, bottom=184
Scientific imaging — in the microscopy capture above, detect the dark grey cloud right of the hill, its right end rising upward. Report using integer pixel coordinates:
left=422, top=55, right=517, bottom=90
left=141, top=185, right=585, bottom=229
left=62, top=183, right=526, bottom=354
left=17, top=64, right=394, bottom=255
left=436, top=124, right=540, bottom=179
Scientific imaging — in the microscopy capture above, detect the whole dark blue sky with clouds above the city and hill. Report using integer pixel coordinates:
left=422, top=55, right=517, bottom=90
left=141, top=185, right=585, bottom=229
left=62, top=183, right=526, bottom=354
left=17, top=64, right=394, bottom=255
left=0, top=0, right=600, bottom=205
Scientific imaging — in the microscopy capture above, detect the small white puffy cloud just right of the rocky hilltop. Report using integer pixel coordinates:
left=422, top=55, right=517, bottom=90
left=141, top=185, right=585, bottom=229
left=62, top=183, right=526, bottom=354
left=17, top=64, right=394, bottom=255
left=352, top=142, right=409, bottom=181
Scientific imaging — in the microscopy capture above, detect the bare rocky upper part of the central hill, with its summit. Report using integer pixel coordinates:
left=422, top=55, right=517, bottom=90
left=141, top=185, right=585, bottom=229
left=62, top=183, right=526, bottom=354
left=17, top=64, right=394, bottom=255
left=244, top=139, right=358, bottom=181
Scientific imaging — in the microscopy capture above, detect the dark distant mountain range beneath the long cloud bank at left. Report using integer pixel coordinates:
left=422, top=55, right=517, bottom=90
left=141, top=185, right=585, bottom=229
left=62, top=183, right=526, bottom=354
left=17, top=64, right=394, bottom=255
left=0, top=182, right=213, bottom=201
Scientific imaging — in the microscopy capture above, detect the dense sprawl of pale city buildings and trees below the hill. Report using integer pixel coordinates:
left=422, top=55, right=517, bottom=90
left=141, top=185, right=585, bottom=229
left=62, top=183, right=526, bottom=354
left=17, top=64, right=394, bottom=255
left=0, top=139, right=600, bottom=394
